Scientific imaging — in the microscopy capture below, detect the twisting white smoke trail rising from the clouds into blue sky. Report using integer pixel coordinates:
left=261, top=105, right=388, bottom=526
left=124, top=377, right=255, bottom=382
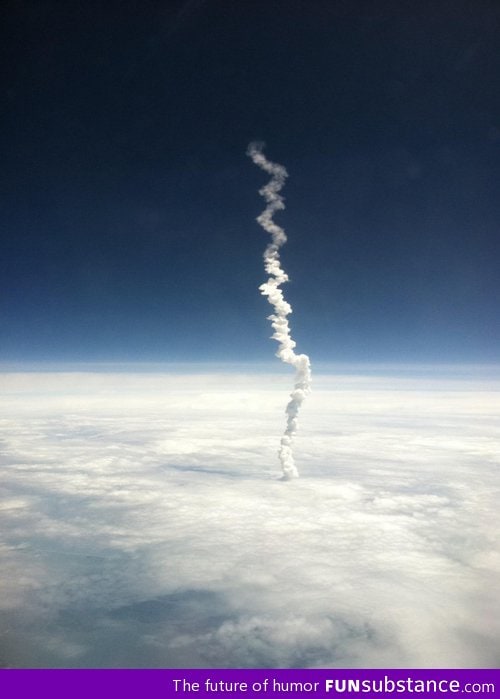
left=247, top=142, right=311, bottom=480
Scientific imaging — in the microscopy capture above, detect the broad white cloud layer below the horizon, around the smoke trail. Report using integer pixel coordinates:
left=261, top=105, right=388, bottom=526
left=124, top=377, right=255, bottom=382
left=0, top=366, right=500, bottom=667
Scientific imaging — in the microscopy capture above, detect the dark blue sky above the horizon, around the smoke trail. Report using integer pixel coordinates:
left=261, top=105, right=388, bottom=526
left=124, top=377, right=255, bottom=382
left=0, top=0, right=500, bottom=362
